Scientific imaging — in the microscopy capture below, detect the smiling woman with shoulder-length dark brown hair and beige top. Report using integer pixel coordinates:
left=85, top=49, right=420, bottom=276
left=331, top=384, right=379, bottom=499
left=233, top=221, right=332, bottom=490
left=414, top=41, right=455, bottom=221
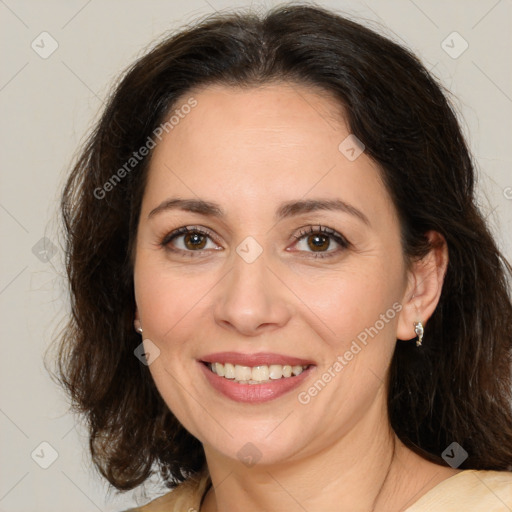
left=55, top=6, right=512, bottom=512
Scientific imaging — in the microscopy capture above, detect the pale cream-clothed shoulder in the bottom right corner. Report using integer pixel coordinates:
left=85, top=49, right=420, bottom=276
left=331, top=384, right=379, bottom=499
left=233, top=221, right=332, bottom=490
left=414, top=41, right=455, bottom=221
left=406, top=469, right=512, bottom=512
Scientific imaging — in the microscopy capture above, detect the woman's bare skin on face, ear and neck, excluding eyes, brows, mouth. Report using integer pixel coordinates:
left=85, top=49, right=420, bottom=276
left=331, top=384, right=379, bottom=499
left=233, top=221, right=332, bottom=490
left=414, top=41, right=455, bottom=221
left=134, top=83, right=457, bottom=512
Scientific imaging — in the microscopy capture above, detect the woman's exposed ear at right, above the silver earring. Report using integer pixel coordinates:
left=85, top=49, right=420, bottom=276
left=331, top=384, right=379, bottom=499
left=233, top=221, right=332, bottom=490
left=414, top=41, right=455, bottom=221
left=397, top=231, right=448, bottom=340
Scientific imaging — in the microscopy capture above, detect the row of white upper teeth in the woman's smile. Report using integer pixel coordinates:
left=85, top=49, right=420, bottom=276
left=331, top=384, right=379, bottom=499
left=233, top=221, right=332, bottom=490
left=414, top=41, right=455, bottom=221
left=208, top=363, right=307, bottom=384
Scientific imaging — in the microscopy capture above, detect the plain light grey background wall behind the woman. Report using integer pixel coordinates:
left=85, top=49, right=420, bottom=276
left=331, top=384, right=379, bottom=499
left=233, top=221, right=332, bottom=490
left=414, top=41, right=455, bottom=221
left=0, top=0, right=512, bottom=512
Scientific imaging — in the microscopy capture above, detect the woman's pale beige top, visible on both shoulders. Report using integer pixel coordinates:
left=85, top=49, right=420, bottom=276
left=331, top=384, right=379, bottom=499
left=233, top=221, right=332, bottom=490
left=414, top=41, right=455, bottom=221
left=127, top=469, right=512, bottom=512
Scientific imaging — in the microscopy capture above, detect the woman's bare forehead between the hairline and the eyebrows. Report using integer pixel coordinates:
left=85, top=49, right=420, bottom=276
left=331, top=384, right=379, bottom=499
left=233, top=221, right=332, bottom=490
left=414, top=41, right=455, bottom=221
left=140, top=83, right=392, bottom=226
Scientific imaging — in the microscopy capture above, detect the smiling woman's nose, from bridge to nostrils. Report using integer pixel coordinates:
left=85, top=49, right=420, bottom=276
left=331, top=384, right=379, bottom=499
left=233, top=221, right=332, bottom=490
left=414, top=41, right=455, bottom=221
left=214, top=251, right=292, bottom=336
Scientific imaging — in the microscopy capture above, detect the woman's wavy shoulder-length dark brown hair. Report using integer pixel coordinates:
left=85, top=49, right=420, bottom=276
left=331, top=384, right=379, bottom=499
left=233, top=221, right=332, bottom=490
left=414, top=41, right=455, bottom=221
left=57, top=5, right=512, bottom=489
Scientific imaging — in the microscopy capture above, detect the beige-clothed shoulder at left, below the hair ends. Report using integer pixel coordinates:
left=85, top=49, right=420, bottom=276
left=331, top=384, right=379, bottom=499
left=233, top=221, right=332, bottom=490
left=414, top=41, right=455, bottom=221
left=122, top=469, right=210, bottom=512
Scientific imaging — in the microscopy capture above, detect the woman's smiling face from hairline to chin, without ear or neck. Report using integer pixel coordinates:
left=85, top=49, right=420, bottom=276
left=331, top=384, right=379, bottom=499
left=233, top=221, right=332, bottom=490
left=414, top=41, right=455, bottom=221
left=135, top=84, right=414, bottom=463
